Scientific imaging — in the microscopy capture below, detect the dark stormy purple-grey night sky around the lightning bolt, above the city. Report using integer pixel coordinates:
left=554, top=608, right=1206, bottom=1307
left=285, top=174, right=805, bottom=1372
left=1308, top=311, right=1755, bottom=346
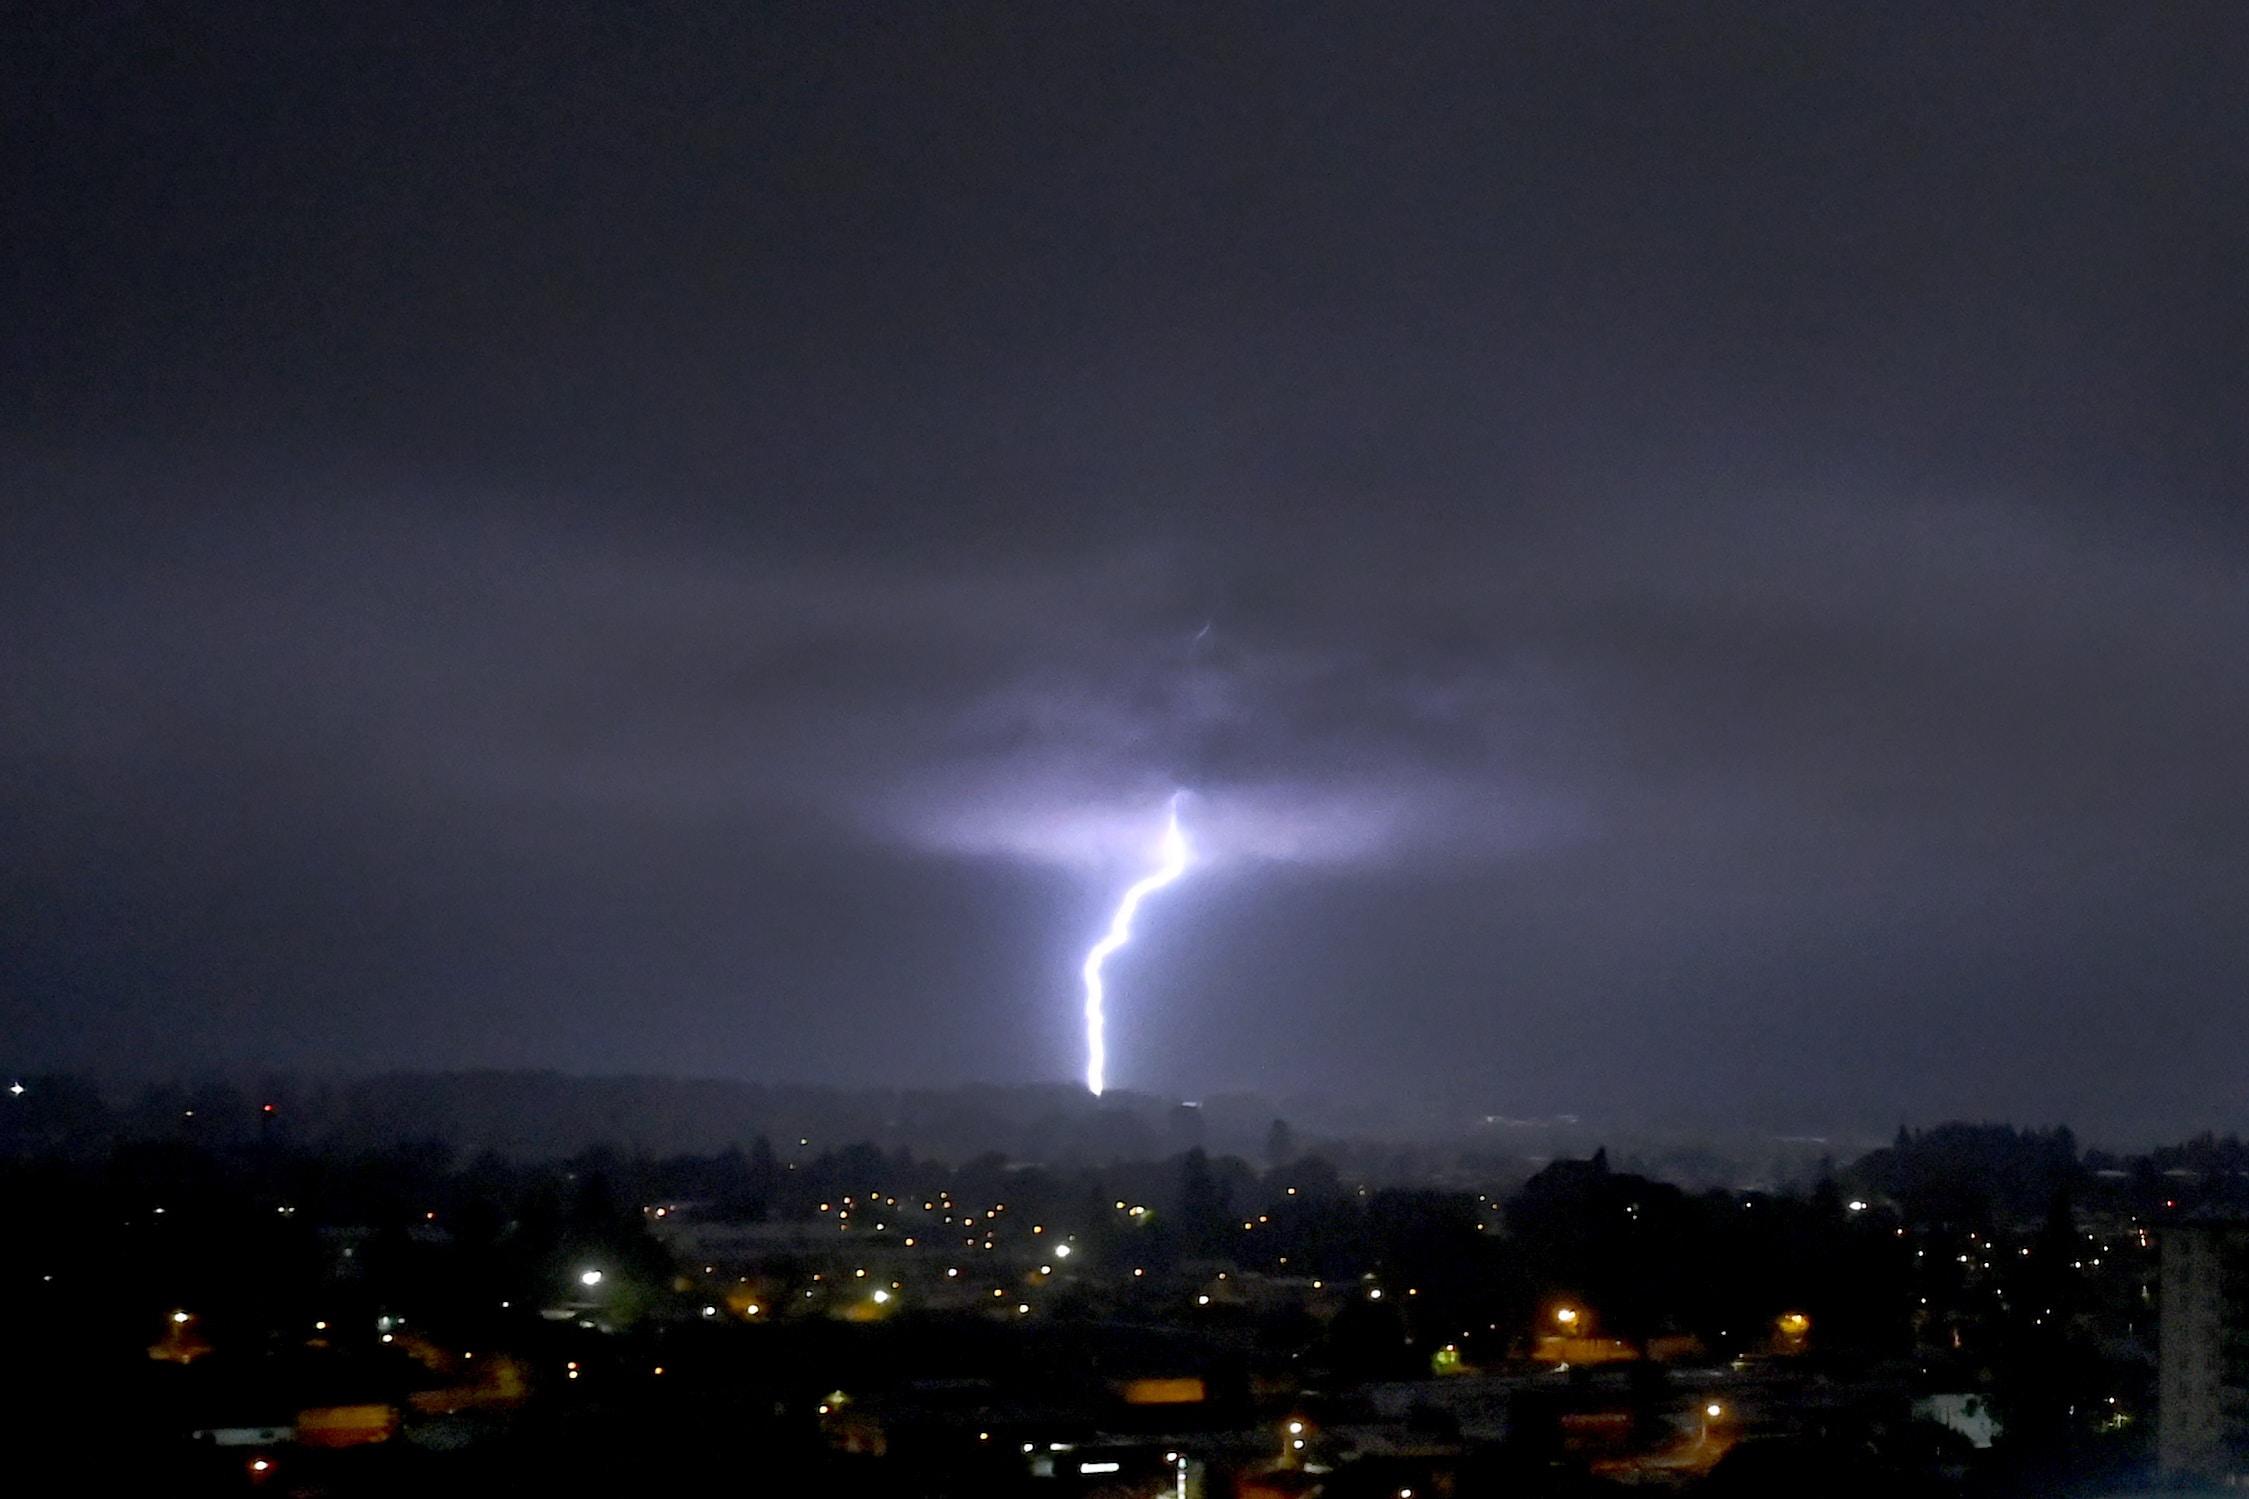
left=0, top=0, right=2249, bottom=1133
